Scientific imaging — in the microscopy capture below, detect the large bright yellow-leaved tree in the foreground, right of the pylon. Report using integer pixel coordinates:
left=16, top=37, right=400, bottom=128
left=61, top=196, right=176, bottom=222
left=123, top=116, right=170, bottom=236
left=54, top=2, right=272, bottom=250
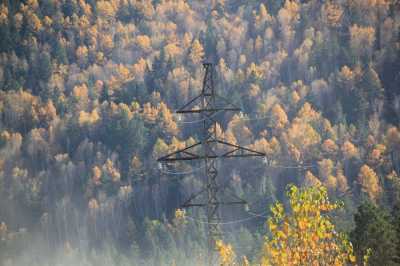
left=261, top=185, right=355, bottom=266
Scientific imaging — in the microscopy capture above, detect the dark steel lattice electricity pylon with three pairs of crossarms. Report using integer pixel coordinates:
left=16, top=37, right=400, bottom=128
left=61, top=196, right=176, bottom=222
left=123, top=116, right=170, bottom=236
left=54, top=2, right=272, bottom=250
left=158, top=63, right=265, bottom=265
